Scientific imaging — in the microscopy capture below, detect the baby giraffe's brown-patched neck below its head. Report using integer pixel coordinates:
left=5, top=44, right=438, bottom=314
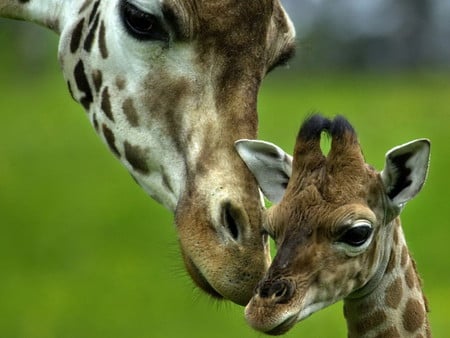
left=344, top=222, right=431, bottom=338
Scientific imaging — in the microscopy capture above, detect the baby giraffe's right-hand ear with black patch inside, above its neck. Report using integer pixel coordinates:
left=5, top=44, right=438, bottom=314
left=381, top=139, right=430, bottom=208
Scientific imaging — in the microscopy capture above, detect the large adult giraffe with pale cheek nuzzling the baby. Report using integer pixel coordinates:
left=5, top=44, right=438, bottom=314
left=0, top=0, right=295, bottom=304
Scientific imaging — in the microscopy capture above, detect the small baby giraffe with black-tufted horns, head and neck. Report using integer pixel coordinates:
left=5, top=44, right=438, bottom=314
left=236, top=115, right=431, bottom=338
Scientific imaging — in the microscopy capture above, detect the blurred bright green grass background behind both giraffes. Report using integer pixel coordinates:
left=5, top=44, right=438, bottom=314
left=0, top=3, right=450, bottom=338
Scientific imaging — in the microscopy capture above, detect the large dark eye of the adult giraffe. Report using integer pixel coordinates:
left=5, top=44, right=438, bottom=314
left=121, top=1, right=169, bottom=41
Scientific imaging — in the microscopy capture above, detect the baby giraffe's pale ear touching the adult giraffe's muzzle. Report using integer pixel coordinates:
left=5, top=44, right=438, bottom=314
left=235, top=139, right=292, bottom=203
